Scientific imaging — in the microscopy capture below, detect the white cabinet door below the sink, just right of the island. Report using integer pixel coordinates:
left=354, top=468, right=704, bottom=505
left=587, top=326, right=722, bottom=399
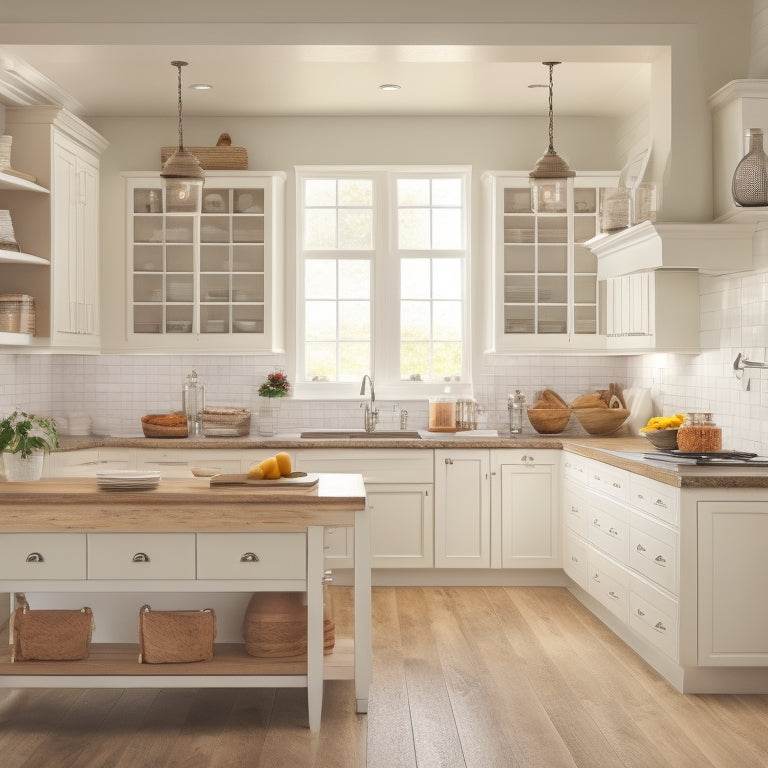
left=366, top=485, right=434, bottom=568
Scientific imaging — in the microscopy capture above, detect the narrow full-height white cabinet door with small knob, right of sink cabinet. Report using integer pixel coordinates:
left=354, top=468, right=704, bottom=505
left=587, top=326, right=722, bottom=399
left=435, top=449, right=491, bottom=568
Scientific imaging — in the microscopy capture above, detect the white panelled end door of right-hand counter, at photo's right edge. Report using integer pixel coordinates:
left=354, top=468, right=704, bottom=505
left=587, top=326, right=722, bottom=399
left=698, top=501, right=768, bottom=666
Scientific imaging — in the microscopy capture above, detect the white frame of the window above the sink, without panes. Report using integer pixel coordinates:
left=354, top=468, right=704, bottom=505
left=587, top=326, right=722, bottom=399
left=294, top=165, right=472, bottom=399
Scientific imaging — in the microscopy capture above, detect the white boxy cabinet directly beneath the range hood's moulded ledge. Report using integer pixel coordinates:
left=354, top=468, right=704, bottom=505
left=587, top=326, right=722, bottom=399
left=601, top=270, right=700, bottom=352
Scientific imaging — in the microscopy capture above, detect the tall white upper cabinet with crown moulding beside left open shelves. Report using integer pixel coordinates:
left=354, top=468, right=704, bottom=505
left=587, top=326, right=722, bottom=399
left=0, top=107, right=107, bottom=351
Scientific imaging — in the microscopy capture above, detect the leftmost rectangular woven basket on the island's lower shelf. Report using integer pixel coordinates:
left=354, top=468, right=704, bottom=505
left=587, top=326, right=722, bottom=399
left=11, top=603, right=93, bottom=661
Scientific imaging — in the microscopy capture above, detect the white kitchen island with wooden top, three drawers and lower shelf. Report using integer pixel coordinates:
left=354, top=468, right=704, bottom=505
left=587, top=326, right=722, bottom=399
left=0, top=474, right=371, bottom=730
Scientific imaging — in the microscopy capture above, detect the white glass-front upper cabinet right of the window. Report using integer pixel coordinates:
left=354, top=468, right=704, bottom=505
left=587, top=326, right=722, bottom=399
left=483, top=172, right=618, bottom=352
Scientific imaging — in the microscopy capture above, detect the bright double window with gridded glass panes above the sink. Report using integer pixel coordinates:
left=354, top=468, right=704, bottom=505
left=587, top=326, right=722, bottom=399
left=296, top=168, right=469, bottom=396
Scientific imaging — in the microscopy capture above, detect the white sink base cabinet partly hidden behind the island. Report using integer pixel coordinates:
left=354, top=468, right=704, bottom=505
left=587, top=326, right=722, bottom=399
left=294, top=448, right=434, bottom=568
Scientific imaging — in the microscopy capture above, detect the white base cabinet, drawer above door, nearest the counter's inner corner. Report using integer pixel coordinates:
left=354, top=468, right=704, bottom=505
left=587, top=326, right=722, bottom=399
left=491, top=449, right=560, bottom=568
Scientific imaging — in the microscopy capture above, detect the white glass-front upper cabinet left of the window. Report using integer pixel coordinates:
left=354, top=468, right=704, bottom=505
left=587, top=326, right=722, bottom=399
left=127, top=171, right=284, bottom=351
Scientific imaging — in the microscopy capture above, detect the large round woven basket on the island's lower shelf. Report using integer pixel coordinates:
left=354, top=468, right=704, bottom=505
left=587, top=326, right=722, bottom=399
left=243, top=592, right=336, bottom=658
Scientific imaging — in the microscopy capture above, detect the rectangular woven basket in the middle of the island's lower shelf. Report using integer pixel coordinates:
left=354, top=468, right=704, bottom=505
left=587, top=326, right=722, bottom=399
left=139, top=605, right=216, bottom=664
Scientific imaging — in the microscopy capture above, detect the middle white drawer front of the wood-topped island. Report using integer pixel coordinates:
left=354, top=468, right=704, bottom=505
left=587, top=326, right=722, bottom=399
left=88, top=533, right=195, bottom=579
